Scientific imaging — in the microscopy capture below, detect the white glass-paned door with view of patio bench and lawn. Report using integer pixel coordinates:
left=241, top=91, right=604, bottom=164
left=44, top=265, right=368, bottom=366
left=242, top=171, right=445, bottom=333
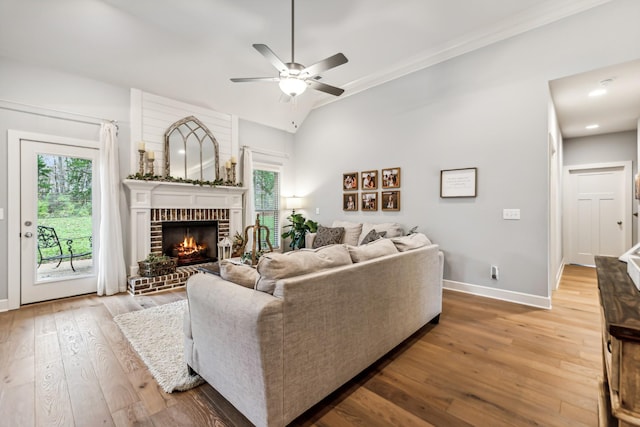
left=20, top=139, right=100, bottom=304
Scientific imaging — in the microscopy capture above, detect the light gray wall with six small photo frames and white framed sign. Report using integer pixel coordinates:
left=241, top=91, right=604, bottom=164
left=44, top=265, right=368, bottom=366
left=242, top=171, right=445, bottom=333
left=295, top=0, right=640, bottom=297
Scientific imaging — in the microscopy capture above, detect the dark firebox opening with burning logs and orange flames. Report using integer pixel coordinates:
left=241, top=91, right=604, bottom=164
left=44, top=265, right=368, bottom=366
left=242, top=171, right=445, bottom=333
left=162, top=221, right=218, bottom=265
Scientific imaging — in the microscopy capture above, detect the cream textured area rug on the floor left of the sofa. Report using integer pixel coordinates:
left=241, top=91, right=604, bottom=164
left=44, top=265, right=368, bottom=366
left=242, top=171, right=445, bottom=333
left=113, top=300, right=203, bottom=393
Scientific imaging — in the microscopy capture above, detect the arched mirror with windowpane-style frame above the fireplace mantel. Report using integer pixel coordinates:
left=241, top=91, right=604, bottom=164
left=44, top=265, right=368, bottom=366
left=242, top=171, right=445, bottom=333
left=164, top=116, right=220, bottom=181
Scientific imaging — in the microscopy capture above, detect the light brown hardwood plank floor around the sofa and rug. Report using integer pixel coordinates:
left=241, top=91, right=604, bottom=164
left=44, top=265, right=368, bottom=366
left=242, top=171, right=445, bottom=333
left=0, top=266, right=602, bottom=427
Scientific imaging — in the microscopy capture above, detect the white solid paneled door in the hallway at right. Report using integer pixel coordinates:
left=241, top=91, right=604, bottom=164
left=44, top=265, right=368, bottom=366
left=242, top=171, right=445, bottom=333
left=564, top=162, right=632, bottom=265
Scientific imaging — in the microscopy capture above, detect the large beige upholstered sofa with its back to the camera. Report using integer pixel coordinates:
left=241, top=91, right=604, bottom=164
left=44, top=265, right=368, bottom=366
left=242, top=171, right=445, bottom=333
left=185, top=235, right=443, bottom=426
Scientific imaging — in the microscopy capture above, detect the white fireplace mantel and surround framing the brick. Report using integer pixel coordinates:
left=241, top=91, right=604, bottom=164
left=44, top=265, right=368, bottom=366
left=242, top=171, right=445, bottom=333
left=122, top=179, right=246, bottom=275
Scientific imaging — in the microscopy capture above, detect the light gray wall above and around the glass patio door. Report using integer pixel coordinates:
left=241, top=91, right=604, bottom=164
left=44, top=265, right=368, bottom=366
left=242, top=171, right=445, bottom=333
left=0, top=58, right=129, bottom=302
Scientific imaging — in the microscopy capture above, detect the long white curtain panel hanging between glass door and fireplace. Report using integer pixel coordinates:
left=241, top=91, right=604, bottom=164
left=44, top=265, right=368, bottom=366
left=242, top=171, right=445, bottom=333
left=98, top=123, right=127, bottom=295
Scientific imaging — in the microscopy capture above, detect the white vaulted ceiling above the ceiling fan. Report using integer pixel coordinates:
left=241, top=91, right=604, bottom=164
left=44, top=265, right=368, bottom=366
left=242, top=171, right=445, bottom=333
left=0, top=0, right=622, bottom=132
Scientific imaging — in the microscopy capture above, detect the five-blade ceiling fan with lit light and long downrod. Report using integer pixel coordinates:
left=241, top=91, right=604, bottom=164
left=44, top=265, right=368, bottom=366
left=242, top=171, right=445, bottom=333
left=231, top=0, right=348, bottom=98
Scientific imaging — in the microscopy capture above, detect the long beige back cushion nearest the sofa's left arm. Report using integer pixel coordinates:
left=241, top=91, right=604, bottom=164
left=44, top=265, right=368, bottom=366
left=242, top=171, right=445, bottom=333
left=256, top=244, right=356, bottom=294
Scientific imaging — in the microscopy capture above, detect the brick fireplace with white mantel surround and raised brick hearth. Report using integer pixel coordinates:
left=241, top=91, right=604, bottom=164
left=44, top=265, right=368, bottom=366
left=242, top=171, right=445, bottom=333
left=123, top=179, right=245, bottom=295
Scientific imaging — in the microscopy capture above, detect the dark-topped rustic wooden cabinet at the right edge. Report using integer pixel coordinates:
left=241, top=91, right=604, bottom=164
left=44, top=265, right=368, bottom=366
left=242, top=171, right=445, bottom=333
left=596, top=256, right=640, bottom=426
